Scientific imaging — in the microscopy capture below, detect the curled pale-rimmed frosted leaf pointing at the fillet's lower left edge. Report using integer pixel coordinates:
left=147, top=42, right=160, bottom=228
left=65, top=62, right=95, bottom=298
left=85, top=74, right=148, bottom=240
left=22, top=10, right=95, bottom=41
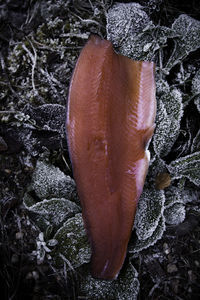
left=24, top=197, right=80, bottom=229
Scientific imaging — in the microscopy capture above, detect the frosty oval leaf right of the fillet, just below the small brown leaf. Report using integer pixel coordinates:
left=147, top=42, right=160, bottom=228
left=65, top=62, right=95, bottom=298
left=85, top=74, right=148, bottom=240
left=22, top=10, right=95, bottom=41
left=134, top=189, right=165, bottom=240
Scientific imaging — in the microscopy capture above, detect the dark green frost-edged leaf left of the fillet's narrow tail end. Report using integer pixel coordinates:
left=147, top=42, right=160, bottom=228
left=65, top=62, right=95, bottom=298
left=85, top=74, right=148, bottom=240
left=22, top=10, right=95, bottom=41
left=54, top=214, right=91, bottom=268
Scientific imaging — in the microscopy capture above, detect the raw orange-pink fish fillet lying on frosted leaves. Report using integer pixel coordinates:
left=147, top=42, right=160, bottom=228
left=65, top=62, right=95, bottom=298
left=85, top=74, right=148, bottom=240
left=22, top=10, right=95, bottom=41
left=67, top=35, right=156, bottom=280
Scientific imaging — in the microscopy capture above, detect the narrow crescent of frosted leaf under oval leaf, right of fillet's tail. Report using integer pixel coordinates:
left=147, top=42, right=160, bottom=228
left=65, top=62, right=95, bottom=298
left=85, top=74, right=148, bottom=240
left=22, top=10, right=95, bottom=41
left=128, top=216, right=165, bottom=253
